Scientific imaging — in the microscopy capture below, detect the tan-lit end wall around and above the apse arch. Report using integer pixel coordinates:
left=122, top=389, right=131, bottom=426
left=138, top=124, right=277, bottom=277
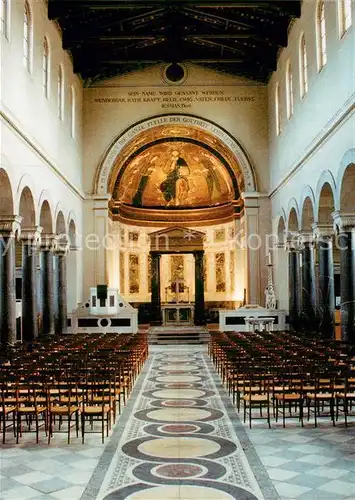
left=84, top=66, right=269, bottom=193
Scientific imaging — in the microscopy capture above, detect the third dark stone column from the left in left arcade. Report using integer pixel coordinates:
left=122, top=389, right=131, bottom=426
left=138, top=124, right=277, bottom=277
left=40, top=234, right=56, bottom=337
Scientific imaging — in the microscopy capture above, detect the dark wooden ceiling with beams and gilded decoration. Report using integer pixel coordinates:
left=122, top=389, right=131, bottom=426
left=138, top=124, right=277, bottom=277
left=48, top=0, right=301, bottom=85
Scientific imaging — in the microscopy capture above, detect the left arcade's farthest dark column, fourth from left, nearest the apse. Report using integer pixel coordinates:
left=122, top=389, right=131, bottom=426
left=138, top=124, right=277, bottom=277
left=55, top=242, right=68, bottom=335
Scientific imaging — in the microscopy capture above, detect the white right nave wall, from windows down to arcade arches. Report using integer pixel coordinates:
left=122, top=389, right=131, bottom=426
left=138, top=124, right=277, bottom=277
left=268, top=0, right=355, bottom=223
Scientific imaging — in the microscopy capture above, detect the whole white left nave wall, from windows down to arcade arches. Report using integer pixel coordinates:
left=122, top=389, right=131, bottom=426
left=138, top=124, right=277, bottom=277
left=0, top=0, right=84, bottom=308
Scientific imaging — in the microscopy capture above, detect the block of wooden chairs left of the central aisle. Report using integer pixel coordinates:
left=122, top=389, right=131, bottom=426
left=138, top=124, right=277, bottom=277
left=0, top=334, right=148, bottom=443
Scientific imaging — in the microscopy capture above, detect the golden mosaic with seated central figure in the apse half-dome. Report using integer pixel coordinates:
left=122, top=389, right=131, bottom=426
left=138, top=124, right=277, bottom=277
left=115, top=140, right=235, bottom=208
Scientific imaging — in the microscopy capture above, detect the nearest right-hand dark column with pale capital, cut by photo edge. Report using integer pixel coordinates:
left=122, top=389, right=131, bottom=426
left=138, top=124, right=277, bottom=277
left=332, top=210, right=355, bottom=343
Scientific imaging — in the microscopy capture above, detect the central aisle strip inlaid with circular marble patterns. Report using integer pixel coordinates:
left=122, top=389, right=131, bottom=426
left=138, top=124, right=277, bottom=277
left=82, top=346, right=279, bottom=500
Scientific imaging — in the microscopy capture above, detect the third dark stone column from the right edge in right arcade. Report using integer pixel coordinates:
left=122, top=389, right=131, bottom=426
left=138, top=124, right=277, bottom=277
left=300, top=233, right=316, bottom=329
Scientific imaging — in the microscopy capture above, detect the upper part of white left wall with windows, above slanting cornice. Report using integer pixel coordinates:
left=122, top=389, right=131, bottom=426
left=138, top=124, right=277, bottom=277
left=0, top=0, right=82, bottom=189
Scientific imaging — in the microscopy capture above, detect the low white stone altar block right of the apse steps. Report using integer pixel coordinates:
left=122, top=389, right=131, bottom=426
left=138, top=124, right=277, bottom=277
left=219, top=305, right=288, bottom=332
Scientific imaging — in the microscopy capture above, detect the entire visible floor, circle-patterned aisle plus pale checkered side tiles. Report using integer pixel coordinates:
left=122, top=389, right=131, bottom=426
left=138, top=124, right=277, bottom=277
left=0, top=345, right=355, bottom=500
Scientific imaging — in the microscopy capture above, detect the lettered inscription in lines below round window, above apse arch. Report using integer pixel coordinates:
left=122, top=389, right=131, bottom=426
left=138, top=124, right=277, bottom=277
left=93, top=90, right=255, bottom=109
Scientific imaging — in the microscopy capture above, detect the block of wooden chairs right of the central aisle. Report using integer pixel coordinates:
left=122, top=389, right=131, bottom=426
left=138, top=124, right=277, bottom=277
left=209, top=332, right=355, bottom=427
